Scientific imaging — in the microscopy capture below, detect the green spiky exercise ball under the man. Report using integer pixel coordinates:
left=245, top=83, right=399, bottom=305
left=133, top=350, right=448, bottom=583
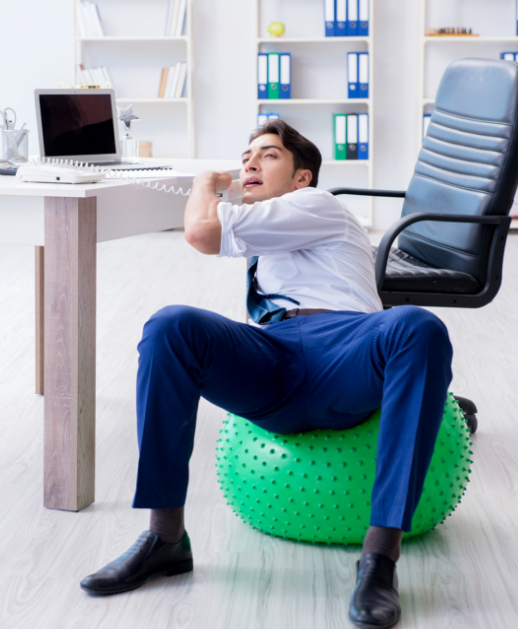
left=217, top=393, right=473, bottom=544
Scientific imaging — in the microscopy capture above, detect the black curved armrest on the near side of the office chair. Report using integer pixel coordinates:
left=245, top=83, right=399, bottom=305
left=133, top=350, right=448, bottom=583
left=376, top=212, right=511, bottom=293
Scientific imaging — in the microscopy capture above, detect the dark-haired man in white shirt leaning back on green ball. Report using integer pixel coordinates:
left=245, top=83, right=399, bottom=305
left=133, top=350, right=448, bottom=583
left=81, top=120, right=452, bottom=627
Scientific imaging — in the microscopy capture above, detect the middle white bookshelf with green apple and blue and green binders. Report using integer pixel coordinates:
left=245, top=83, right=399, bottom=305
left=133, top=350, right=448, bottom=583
left=252, top=0, right=374, bottom=229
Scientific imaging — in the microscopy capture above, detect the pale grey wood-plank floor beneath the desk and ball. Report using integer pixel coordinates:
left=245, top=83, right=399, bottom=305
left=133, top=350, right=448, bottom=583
left=0, top=232, right=518, bottom=629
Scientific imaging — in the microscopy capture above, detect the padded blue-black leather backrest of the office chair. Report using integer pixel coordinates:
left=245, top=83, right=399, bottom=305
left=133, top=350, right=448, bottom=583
left=398, top=59, right=518, bottom=285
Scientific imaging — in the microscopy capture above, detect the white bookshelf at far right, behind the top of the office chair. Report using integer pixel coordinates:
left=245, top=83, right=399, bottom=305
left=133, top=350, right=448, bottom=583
left=417, top=0, right=518, bottom=152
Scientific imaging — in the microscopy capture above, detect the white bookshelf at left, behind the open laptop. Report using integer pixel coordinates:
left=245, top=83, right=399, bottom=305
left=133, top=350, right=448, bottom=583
left=72, top=0, right=195, bottom=158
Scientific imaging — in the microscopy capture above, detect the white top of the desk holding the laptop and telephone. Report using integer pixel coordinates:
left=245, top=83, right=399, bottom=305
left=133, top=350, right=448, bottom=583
left=0, top=158, right=241, bottom=198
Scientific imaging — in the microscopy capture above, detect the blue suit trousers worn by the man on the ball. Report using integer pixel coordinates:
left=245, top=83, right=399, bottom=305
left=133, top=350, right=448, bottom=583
left=133, top=306, right=452, bottom=531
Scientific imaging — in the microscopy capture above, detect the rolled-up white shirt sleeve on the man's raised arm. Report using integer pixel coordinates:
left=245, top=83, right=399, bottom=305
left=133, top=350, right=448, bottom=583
left=218, top=188, right=348, bottom=258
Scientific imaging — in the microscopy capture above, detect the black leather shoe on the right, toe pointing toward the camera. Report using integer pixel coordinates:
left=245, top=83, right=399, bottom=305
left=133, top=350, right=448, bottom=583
left=349, top=553, right=401, bottom=629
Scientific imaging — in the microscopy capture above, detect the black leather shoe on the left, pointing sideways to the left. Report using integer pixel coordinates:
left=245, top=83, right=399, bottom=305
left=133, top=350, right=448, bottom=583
left=81, top=531, right=192, bottom=594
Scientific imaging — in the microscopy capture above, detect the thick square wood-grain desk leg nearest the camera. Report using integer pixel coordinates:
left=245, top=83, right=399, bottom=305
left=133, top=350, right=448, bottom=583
left=44, top=197, right=97, bottom=511
